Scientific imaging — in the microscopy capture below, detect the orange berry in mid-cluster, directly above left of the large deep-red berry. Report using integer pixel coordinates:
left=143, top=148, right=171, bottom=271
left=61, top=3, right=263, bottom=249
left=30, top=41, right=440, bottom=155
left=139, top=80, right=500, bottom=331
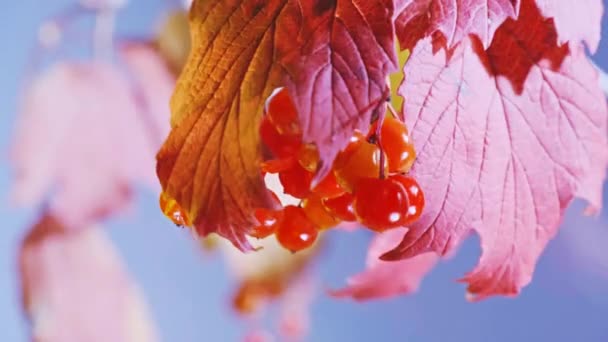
left=334, top=140, right=388, bottom=192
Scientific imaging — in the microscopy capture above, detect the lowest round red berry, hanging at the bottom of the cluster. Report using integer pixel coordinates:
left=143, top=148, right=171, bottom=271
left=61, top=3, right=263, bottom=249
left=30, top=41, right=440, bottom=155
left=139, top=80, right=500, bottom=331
left=275, top=205, right=319, bottom=252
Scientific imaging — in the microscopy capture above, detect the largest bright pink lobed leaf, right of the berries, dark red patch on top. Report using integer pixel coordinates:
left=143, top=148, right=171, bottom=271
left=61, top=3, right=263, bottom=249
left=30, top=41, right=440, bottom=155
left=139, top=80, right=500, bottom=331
left=382, top=1, right=608, bottom=299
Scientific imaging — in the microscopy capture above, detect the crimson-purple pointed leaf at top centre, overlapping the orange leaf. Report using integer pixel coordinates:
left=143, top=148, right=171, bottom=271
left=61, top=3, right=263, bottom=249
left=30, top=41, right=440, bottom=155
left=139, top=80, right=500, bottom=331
left=276, top=0, right=397, bottom=175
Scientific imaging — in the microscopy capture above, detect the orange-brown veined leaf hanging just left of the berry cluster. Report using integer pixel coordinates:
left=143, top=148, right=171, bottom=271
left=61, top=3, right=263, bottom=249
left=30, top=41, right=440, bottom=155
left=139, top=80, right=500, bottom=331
left=157, top=0, right=287, bottom=250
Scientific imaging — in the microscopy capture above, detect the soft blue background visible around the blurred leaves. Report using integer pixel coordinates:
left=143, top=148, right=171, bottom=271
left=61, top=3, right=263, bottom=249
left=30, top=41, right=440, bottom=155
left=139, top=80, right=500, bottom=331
left=0, top=0, right=608, bottom=342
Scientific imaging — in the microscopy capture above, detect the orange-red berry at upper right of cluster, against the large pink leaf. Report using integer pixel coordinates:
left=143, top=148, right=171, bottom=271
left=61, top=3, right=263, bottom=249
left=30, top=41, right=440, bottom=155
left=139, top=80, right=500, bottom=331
left=368, top=117, right=416, bottom=173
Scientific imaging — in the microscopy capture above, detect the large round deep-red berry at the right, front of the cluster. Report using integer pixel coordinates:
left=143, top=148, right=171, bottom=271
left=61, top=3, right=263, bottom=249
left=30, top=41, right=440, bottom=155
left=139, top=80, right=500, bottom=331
left=354, top=178, right=409, bottom=231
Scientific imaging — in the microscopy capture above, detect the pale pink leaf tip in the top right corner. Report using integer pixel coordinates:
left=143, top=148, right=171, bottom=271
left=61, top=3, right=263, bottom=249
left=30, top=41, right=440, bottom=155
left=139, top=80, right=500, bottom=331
left=536, top=0, right=604, bottom=52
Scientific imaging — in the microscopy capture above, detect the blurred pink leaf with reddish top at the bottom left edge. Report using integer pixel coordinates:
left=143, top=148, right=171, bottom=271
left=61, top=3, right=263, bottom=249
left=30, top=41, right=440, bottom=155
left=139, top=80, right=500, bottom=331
left=19, top=216, right=157, bottom=342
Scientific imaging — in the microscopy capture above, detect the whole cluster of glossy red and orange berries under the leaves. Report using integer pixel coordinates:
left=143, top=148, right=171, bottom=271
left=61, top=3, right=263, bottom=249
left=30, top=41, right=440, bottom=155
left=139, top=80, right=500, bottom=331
left=251, top=89, right=424, bottom=252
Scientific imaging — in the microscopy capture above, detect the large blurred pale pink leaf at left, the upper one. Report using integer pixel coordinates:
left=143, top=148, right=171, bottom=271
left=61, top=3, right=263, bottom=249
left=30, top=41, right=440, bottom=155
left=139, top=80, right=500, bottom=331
left=12, top=62, right=158, bottom=227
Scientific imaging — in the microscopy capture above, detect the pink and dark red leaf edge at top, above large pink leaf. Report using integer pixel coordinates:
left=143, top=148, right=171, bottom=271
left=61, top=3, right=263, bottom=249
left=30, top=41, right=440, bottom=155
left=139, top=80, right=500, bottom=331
left=395, top=0, right=521, bottom=49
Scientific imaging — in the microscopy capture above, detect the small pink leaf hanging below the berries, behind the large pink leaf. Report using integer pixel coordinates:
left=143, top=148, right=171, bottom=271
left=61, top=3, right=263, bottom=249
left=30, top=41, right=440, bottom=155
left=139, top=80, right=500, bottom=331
left=331, top=229, right=438, bottom=300
